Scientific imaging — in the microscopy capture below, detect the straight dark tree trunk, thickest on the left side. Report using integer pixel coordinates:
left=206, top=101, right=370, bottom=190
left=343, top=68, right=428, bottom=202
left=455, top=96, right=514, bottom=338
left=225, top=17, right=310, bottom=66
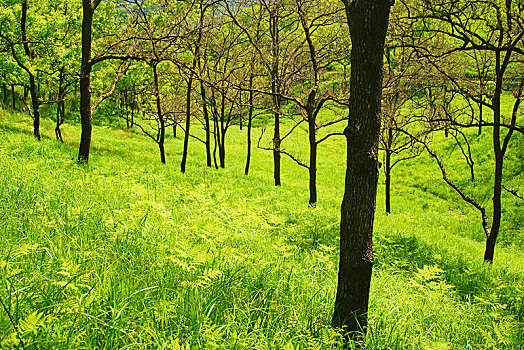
left=78, top=0, right=95, bottom=164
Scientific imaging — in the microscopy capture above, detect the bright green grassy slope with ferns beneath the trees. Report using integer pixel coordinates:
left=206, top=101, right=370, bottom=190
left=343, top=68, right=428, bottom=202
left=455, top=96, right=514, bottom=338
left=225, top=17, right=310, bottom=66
left=0, top=111, right=524, bottom=349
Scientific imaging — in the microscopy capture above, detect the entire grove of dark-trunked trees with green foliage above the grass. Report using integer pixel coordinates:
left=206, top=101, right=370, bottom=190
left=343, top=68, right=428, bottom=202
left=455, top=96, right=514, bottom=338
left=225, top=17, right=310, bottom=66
left=0, top=0, right=524, bottom=338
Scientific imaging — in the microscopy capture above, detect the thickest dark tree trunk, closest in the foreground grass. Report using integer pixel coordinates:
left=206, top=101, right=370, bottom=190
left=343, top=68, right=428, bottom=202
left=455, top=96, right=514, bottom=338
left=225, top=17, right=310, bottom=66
left=332, top=0, right=392, bottom=340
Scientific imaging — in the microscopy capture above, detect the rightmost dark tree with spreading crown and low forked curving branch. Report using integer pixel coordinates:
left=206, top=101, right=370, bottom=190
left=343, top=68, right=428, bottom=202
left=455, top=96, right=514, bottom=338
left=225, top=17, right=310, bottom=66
left=406, top=0, right=524, bottom=263
